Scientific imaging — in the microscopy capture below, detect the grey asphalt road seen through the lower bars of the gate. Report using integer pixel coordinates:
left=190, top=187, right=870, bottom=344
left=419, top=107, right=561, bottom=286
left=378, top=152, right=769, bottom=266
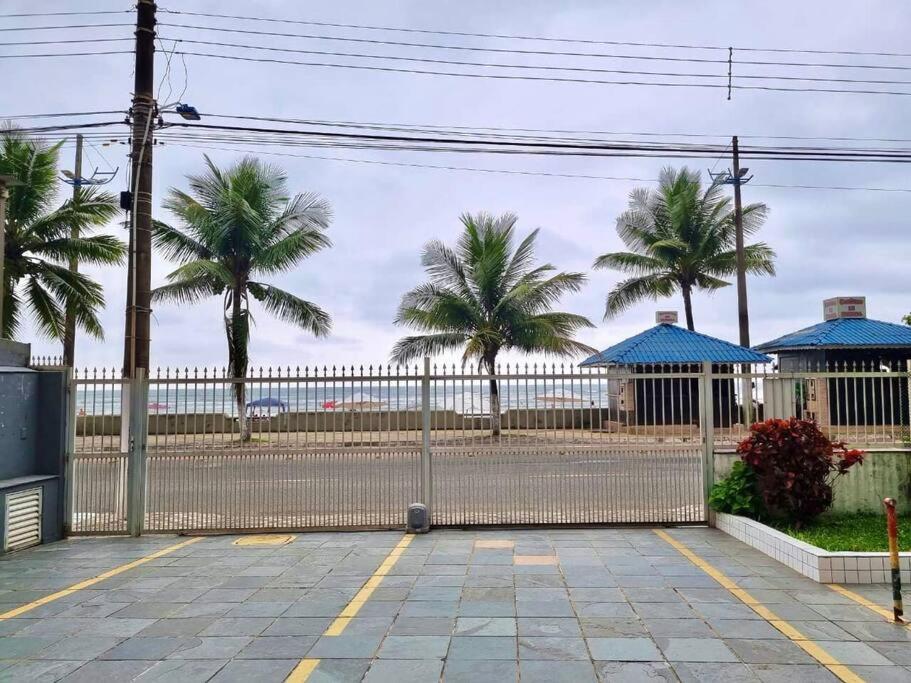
left=74, top=445, right=704, bottom=532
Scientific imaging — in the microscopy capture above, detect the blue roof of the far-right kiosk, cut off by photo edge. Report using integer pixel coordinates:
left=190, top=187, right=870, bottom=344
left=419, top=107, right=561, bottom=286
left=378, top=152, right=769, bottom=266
left=755, top=318, right=911, bottom=353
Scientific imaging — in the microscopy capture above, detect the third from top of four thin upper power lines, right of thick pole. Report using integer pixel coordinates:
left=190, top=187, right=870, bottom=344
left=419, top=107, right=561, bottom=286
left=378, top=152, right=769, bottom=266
left=157, top=38, right=911, bottom=87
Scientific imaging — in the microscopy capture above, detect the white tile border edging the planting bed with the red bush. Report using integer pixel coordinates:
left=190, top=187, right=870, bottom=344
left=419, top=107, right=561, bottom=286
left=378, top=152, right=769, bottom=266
left=715, top=512, right=911, bottom=584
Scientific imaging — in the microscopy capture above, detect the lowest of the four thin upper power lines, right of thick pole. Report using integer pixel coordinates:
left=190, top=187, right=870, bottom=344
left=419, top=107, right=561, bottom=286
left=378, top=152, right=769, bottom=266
left=171, top=50, right=911, bottom=96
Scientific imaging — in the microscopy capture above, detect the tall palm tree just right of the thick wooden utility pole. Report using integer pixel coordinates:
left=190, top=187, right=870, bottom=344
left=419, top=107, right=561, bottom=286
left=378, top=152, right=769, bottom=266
left=152, top=156, right=331, bottom=440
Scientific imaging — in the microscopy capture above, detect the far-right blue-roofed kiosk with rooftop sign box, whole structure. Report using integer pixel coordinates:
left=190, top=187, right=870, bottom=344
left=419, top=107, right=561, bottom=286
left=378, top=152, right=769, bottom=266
left=755, top=296, right=911, bottom=425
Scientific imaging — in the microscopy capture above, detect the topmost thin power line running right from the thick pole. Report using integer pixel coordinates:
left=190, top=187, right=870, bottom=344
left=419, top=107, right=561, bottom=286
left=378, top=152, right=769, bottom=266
left=162, top=9, right=911, bottom=57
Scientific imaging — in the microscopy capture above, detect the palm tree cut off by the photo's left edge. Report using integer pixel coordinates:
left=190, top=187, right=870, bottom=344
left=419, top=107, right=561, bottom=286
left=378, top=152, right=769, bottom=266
left=0, top=130, right=126, bottom=341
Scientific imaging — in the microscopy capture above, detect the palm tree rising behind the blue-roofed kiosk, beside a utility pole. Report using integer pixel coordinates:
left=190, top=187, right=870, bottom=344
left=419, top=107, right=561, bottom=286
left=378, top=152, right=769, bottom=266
left=594, top=166, right=775, bottom=330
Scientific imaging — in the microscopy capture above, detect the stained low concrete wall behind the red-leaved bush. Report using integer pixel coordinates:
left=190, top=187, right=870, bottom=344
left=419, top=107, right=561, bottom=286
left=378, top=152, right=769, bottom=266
left=715, top=449, right=911, bottom=515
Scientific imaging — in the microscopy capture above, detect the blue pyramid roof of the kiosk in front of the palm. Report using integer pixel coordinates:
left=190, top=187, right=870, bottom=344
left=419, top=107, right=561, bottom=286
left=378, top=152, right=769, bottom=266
left=582, top=323, right=772, bottom=367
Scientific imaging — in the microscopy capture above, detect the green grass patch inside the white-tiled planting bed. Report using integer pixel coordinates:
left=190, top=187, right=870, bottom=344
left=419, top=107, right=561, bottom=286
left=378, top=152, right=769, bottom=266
left=770, top=512, right=911, bottom=552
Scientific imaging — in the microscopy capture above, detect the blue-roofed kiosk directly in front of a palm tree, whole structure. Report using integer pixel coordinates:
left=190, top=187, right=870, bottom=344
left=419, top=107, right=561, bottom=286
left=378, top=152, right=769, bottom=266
left=581, top=311, right=772, bottom=426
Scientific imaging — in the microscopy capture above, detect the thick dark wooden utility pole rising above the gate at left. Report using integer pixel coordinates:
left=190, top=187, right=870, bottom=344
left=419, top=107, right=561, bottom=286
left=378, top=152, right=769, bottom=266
left=123, top=0, right=157, bottom=377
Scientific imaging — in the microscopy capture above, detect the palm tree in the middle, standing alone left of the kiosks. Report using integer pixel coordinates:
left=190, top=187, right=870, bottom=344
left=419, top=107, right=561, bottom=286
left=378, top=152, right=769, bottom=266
left=392, top=213, right=594, bottom=436
